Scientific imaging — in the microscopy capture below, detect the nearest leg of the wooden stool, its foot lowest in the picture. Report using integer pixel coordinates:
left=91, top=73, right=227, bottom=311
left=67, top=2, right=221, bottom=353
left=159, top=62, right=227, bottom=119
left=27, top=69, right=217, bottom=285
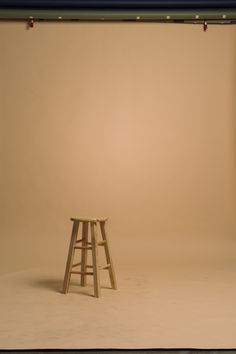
left=90, top=222, right=101, bottom=297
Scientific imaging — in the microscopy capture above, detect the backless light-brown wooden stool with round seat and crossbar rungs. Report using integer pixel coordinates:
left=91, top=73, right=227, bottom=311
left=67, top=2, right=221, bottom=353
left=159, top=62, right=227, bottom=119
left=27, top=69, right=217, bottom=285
left=62, top=218, right=117, bottom=297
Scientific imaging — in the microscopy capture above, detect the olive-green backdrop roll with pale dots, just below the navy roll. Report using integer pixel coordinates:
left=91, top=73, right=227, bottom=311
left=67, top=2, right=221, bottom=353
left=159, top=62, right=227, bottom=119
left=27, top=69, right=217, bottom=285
left=0, top=8, right=236, bottom=23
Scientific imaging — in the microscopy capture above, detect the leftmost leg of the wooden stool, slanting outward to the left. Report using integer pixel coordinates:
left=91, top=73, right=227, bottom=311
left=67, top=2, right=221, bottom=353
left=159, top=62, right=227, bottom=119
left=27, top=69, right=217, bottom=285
left=62, top=221, right=79, bottom=294
